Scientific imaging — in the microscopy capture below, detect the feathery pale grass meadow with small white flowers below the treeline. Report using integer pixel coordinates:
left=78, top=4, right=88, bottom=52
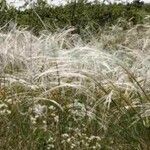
left=0, top=24, right=150, bottom=150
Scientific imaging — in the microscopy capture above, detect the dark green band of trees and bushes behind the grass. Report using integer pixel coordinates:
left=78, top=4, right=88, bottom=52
left=0, top=0, right=150, bottom=34
